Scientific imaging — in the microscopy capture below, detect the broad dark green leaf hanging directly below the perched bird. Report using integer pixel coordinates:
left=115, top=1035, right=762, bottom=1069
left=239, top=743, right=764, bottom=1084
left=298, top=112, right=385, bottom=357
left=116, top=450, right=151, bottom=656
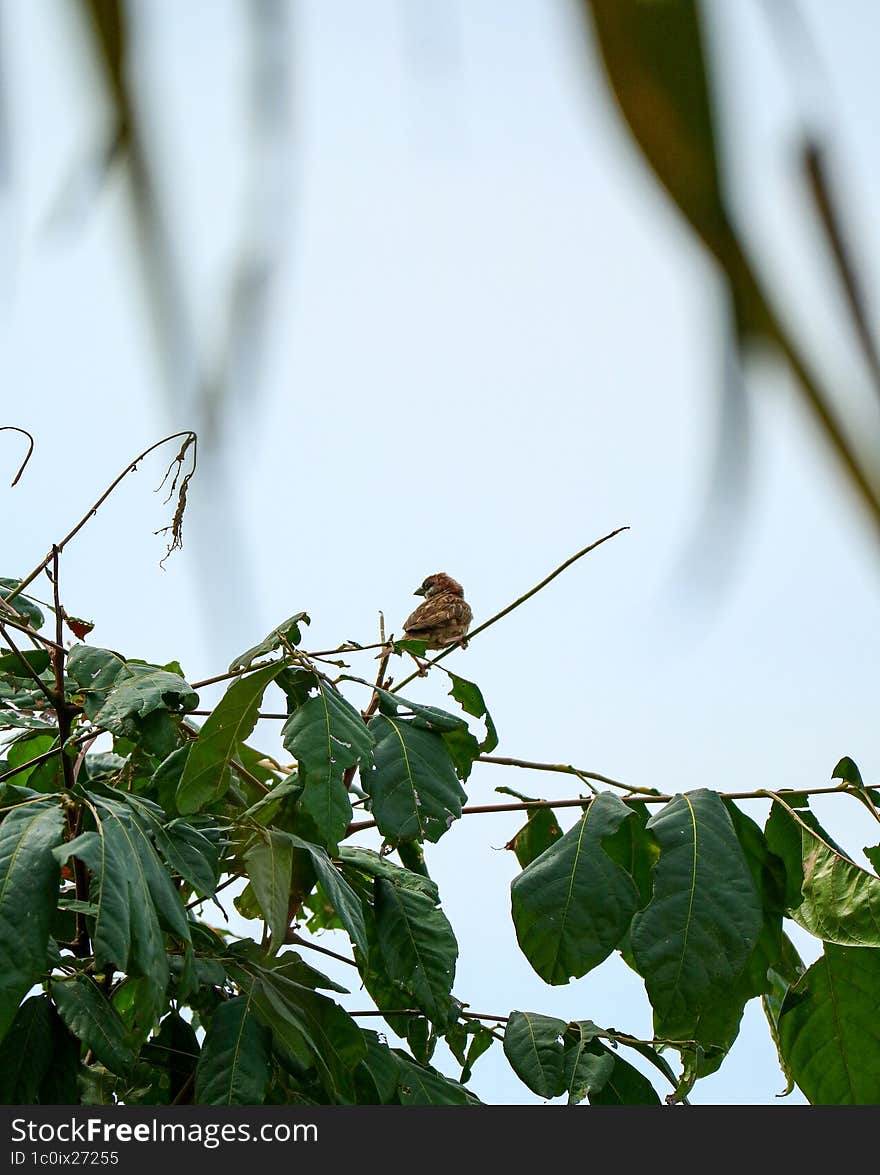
left=361, top=714, right=468, bottom=842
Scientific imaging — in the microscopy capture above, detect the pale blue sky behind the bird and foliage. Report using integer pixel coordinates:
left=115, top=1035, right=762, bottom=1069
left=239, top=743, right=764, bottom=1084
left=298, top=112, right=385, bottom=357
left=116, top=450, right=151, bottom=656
left=0, top=0, right=880, bottom=1105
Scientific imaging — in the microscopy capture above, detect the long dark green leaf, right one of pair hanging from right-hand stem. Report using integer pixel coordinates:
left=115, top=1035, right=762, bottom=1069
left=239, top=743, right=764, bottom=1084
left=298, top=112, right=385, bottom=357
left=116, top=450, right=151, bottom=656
left=631, top=790, right=763, bottom=1040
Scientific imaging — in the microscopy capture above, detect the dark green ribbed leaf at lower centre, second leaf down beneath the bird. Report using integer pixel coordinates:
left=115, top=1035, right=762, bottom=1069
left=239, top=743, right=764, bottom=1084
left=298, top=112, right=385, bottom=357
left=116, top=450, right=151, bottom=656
left=375, top=878, right=458, bottom=1026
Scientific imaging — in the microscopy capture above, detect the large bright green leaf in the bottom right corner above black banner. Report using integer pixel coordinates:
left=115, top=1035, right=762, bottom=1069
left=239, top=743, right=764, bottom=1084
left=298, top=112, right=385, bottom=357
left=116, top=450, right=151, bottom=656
left=778, top=942, right=880, bottom=1106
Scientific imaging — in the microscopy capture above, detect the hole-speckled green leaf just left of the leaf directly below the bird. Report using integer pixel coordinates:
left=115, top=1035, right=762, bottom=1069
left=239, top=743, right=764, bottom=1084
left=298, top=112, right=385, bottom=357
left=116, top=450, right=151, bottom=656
left=281, top=676, right=372, bottom=852
